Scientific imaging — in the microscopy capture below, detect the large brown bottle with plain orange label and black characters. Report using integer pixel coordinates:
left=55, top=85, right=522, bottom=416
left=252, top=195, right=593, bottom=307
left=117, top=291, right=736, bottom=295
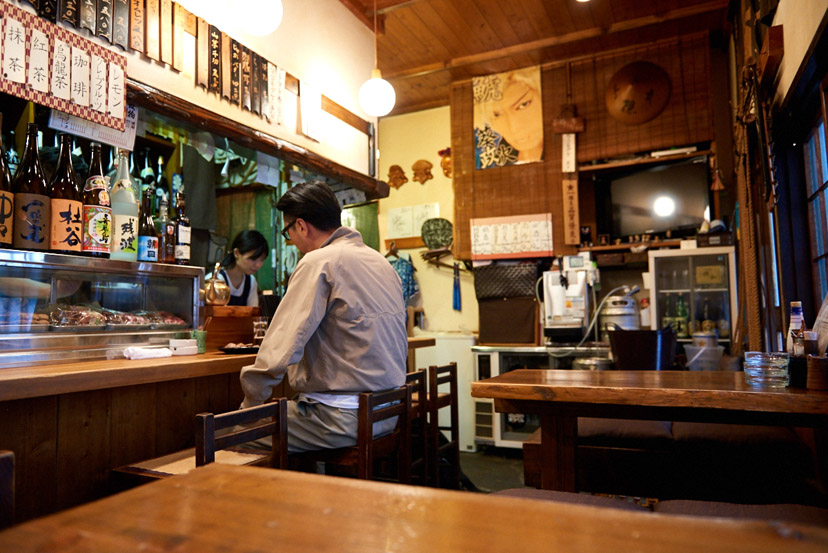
left=50, top=133, right=83, bottom=254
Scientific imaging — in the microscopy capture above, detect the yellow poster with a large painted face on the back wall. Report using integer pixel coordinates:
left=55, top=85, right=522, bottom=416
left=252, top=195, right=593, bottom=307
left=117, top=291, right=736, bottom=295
left=472, top=66, right=543, bottom=169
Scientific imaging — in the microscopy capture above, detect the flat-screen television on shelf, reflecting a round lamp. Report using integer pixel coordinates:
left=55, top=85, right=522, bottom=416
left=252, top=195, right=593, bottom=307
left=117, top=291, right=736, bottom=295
left=596, top=156, right=710, bottom=238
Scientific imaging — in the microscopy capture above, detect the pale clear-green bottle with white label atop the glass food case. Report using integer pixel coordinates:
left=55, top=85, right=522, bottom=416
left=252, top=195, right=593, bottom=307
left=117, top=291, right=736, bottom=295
left=109, top=150, right=138, bottom=261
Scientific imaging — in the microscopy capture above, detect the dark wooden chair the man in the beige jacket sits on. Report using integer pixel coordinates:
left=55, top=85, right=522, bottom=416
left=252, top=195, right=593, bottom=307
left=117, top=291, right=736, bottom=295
left=290, top=385, right=411, bottom=484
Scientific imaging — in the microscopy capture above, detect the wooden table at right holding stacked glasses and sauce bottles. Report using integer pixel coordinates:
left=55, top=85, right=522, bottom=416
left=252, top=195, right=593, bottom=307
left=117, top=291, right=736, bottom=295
left=471, top=369, right=828, bottom=491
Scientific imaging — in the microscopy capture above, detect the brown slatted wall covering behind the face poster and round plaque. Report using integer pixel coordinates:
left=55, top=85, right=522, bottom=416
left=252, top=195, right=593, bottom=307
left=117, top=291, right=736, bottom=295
left=451, top=33, right=713, bottom=259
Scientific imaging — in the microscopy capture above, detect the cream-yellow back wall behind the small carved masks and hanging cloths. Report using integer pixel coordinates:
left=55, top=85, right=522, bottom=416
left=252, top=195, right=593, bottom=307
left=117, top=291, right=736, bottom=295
left=378, top=107, right=478, bottom=334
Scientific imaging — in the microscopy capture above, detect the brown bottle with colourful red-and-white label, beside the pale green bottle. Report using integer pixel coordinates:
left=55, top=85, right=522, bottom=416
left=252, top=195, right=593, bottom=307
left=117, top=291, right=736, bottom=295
left=82, top=142, right=112, bottom=257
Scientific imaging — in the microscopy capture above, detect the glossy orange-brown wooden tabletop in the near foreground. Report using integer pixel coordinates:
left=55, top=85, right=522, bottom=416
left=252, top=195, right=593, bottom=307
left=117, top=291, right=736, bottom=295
left=0, top=464, right=828, bottom=553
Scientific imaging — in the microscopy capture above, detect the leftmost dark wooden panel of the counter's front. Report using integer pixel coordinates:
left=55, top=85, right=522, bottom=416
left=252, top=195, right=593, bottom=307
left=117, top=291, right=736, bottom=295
left=0, top=396, right=57, bottom=521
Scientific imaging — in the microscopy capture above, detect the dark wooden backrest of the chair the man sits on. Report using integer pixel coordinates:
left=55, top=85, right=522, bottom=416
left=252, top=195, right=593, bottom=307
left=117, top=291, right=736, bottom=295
left=356, top=385, right=411, bottom=483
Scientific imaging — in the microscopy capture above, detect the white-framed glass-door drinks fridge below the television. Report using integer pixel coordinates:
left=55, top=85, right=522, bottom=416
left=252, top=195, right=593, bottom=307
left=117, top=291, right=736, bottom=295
left=649, top=246, right=737, bottom=346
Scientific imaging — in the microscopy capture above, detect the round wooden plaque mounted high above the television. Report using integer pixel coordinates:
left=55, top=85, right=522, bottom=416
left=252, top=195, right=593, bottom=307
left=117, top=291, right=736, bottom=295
left=604, top=61, right=670, bottom=125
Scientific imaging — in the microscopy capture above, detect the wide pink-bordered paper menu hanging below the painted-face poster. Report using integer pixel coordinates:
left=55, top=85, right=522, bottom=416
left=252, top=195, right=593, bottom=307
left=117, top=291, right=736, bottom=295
left=470, top=213, right=553, bottom=260
